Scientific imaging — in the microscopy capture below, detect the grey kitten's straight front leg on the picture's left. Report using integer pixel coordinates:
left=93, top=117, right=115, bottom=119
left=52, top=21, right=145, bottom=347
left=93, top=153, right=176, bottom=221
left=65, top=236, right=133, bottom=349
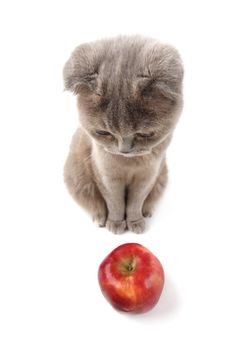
left=103, top=179, right=126, bottom=233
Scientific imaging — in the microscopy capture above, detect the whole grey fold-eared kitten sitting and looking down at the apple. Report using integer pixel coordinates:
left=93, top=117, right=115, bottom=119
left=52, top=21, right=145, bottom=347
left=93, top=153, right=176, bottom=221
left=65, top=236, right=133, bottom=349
left=64, top=36, right=183, bottom=233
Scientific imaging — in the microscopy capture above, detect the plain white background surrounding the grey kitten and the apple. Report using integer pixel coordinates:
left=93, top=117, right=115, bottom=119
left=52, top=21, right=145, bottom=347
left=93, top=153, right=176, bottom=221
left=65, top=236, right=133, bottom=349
left=0, top=0, right=233, bottom=350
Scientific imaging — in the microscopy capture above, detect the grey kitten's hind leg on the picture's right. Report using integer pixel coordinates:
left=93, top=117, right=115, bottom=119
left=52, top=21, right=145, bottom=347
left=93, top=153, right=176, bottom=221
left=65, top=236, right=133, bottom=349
left=142, top=161, right=168, bottom=217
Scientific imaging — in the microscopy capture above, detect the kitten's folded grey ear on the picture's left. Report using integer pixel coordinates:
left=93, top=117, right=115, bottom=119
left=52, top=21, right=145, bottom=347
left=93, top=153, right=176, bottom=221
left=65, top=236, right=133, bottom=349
left=63, top=44, right=98, bottom=95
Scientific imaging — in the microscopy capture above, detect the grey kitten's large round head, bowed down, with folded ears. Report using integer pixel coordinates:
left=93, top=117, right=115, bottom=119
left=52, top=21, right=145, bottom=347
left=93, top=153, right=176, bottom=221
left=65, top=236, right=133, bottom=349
left=64, top=36, right=183, bottom=156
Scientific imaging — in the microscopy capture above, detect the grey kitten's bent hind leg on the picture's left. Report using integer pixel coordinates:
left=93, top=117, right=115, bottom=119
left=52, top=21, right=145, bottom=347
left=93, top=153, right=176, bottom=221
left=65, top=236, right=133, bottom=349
left=64, top=153, right=107, bottom=227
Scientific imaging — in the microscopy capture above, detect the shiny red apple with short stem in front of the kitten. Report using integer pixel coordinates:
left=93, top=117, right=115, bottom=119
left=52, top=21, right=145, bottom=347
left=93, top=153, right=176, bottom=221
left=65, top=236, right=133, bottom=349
left=98, top=243, right=164, bottom=313
